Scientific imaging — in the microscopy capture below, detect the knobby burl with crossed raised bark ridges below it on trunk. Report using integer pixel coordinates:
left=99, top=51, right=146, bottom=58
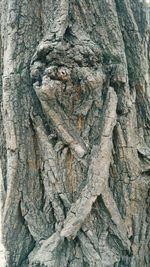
left=27, top=28, right=130, bottom=266
